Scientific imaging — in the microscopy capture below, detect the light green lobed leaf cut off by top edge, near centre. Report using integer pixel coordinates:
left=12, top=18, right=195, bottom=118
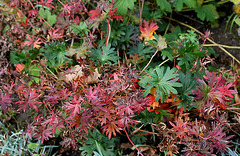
left=115, top=0, right=136, bottom=15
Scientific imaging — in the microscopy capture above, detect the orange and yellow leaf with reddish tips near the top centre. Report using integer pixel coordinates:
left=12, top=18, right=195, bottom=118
left=139, top=20, right=158, bottom=41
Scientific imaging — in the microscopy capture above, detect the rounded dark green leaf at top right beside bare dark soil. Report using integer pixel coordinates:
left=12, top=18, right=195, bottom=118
left=195, top=4, right=219, bottom=22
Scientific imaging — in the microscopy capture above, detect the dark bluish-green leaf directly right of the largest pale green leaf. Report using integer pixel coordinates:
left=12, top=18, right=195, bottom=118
left=177, top=72, right=197, bottom=110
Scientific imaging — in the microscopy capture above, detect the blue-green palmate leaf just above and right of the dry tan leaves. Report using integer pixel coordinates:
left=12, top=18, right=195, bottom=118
left=87, top=44, right=119, bottom=65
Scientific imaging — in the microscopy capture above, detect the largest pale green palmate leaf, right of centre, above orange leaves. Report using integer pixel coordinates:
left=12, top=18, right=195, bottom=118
left=139, top=67, right=182, bottom=102
